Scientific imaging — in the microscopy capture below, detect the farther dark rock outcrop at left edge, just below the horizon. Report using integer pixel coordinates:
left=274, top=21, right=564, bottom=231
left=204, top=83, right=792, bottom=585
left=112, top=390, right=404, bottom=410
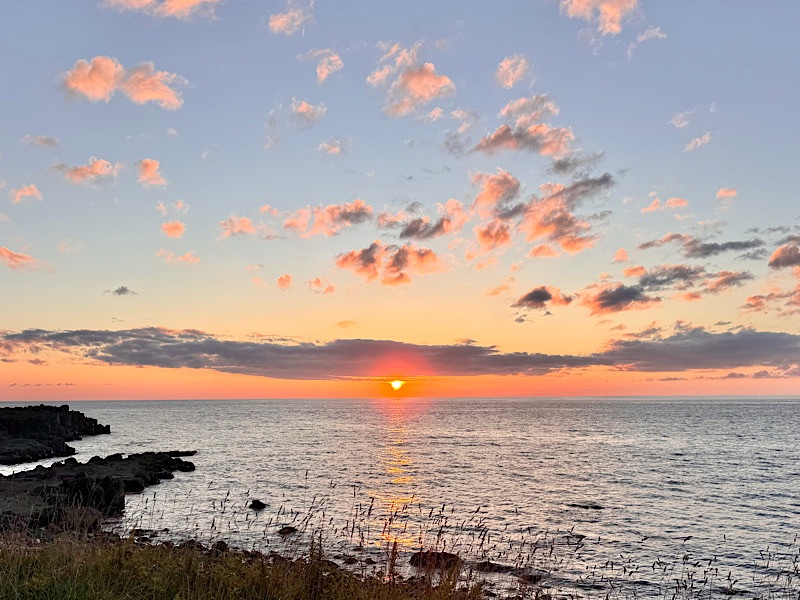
left=0, top=404, right=111, bottom=465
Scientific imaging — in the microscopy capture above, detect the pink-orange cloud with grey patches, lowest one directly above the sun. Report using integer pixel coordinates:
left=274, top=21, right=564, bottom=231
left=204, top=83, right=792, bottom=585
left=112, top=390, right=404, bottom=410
left=336, top=241, right=442, bottom=286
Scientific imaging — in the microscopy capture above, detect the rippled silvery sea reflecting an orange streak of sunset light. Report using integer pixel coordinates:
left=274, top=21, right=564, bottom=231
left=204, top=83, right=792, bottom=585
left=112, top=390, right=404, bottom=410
left=5, top=398, right=800, bottom=595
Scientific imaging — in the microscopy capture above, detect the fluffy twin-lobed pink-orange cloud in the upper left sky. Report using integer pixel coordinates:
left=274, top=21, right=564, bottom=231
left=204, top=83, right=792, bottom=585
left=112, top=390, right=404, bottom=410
left=64, top=56, right=186, bottom=110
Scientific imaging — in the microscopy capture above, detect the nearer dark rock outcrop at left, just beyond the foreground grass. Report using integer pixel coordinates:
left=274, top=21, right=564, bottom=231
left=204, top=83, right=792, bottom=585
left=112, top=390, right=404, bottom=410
left=0, top=451, right=195, bottom=529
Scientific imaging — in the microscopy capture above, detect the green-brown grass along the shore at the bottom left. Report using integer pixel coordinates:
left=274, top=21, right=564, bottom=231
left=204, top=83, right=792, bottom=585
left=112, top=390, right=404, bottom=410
left=0, top=535, right=481, bottom=600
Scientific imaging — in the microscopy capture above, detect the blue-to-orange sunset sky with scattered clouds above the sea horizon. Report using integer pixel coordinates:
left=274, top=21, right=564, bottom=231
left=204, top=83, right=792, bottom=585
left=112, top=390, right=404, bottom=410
left=0, top=0, right=800, bottom=401
